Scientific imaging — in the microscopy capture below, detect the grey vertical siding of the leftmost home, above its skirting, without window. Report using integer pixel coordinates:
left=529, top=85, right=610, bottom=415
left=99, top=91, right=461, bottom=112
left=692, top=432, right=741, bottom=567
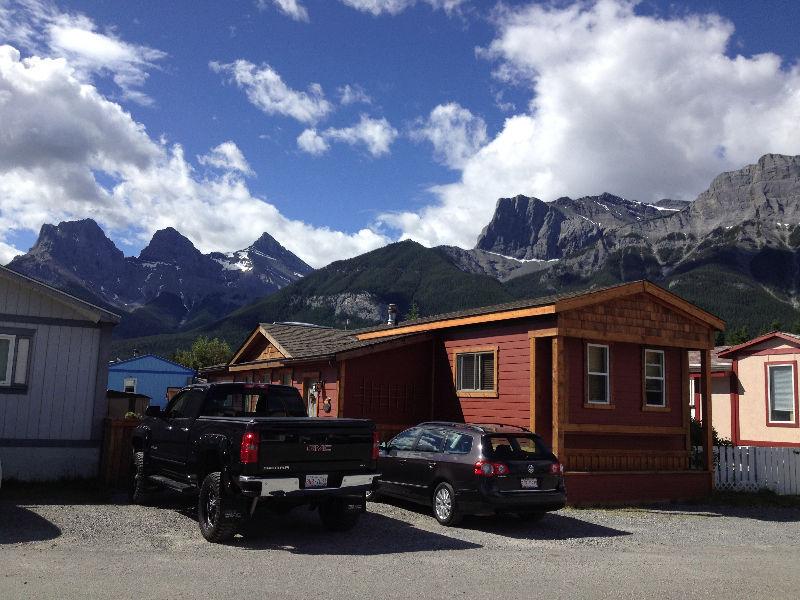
left=0, top=278, right=111, bottom=440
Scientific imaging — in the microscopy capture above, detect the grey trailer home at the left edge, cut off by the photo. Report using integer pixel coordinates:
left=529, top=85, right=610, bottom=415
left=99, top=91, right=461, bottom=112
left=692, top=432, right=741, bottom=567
left=0, top=267, right=119, bottom=481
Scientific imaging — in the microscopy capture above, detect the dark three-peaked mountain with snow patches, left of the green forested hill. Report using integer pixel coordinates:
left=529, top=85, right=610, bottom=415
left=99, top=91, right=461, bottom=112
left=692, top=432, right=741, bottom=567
left=8, top=219, right=312, bottom=337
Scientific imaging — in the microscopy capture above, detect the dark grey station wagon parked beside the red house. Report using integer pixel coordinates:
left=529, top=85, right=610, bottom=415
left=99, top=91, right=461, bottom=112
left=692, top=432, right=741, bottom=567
left=370, top=422, right=566, bottom=525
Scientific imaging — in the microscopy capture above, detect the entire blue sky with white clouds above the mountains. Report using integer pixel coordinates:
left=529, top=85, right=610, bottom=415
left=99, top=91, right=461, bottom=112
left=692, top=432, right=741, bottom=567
left=0, top=0, right=800, bottom=267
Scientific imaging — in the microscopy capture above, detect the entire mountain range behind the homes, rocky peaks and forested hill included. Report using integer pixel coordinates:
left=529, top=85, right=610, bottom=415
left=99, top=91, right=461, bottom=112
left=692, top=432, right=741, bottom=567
left=9, top=154, right=800, bottom=354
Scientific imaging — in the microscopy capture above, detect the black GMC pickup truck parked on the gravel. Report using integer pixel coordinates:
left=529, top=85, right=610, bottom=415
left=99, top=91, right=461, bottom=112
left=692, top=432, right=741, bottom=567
left=130, top=383, right=378, bottom=542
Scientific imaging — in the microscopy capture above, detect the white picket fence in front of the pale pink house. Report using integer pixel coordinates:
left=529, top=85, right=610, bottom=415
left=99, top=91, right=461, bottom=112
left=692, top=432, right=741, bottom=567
left=714, top=446, right=800, bottom=494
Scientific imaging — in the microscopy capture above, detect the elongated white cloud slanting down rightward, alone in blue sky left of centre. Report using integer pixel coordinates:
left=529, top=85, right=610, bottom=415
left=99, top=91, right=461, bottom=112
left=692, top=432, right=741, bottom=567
left=209, top=59, right=333, bottom=123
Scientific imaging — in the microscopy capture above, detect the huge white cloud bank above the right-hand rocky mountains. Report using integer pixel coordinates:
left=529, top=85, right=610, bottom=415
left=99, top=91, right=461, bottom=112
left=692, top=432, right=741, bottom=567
left=382, top=0, right=800, bottom=247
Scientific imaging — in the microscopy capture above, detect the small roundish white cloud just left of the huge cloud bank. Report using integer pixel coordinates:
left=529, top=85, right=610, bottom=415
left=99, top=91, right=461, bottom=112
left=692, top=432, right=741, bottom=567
left=411, top=102, right=487, bottom=169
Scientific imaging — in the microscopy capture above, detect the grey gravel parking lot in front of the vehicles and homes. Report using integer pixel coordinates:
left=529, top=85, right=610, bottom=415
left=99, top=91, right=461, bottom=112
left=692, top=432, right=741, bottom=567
left=0, top=489, right=800, bottom=599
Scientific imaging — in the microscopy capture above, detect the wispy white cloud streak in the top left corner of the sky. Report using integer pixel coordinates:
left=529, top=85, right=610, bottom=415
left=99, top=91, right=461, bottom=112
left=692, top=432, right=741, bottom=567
left=0, top=0, right=167, bottom=104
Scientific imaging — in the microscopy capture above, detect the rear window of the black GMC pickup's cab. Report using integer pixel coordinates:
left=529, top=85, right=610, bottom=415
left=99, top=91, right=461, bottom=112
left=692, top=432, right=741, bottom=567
left=202, top=385, right=307, bottom=417
